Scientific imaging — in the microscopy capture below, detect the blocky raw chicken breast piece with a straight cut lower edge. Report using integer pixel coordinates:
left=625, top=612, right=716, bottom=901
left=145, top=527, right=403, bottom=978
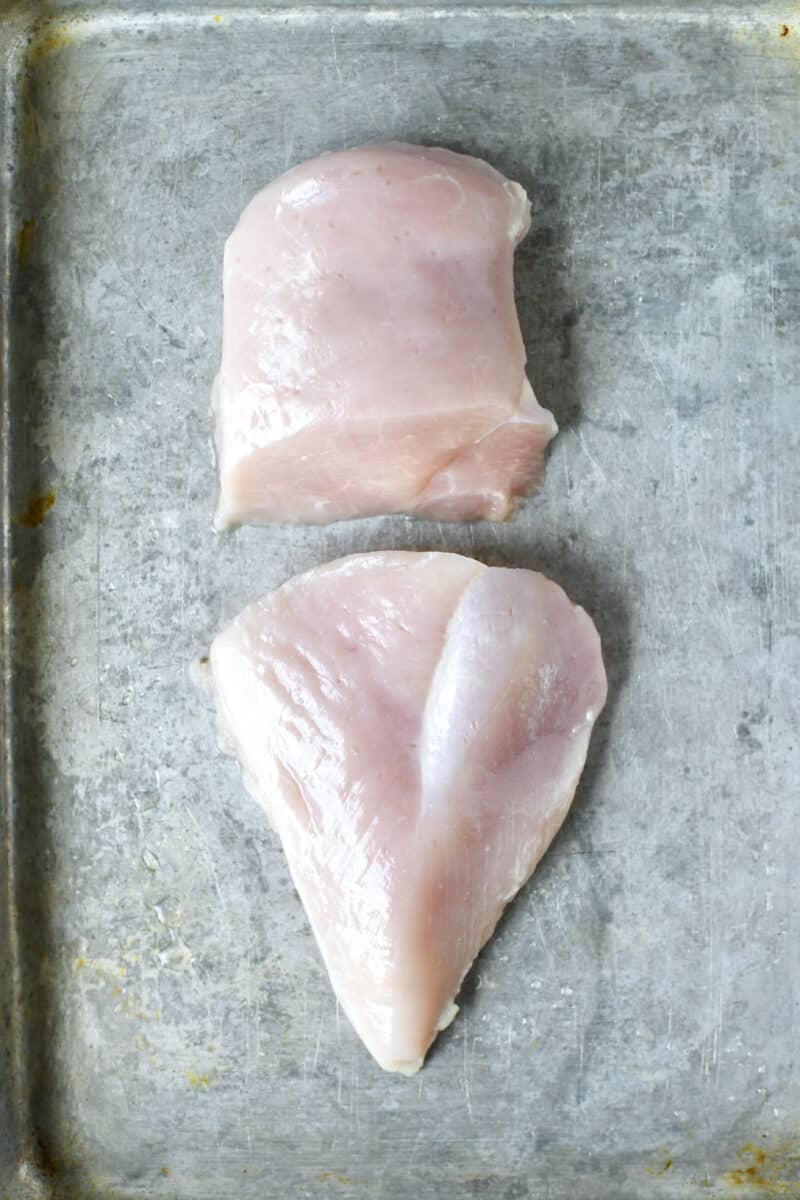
left=215, top=144, right=557, bottom=528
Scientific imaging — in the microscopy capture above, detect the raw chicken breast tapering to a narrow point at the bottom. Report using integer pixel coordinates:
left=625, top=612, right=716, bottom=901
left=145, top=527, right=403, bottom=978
left=203, top=553, right=606, bottom=1074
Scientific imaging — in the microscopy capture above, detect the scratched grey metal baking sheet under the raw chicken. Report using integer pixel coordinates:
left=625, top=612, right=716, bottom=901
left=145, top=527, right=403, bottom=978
left=0, top=4, right=800, bottom=1200
